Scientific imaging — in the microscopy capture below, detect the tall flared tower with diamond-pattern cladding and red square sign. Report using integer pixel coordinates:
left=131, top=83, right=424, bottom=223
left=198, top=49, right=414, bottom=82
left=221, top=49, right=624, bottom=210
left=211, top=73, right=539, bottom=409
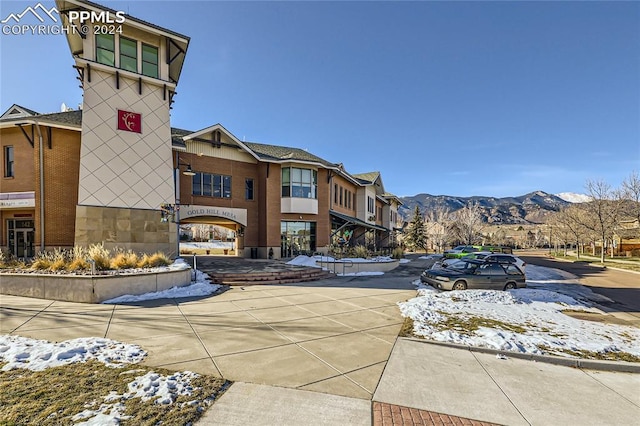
left=56, top=0, right=189, bottom=253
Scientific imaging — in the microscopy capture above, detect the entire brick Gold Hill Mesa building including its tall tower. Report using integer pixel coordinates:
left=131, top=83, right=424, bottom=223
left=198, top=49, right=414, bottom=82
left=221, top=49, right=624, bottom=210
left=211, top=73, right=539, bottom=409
left=0, top=0, right=400, bottom=258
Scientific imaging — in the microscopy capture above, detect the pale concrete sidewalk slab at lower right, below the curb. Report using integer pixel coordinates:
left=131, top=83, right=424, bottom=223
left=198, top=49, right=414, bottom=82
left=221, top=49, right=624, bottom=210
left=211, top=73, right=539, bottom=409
left=373, top=338, right=640, bottom=425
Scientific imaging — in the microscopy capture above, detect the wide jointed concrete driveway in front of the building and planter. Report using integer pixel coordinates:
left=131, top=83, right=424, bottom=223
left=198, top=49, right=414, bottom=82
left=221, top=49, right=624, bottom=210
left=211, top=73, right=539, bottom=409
left=0, top=260, right=423, bottom=400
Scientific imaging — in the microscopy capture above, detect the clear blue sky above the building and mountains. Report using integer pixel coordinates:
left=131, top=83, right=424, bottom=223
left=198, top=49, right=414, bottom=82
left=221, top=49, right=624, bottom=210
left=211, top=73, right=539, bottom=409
left=0, top=0, right=640, bottom=197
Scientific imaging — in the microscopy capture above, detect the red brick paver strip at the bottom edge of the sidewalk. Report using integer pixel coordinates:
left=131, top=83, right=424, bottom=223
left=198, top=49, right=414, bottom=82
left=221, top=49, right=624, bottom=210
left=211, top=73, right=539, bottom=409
left=373, top=402, right=498, bottom=426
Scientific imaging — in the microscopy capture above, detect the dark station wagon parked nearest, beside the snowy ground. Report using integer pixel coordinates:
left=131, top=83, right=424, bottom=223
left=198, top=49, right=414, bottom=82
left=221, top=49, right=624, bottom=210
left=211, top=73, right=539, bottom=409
left=420, top=259, right=527, bottom=290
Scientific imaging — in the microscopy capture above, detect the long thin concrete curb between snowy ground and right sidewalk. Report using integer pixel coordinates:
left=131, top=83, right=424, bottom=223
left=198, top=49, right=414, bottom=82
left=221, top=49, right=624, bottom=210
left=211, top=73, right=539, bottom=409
left=398, top=337, right=640, bottom=374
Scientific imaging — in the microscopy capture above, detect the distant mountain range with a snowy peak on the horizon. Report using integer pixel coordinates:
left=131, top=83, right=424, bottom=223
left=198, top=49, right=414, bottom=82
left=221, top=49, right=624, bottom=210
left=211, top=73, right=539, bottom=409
left=398, top=191, right=588, bottom=225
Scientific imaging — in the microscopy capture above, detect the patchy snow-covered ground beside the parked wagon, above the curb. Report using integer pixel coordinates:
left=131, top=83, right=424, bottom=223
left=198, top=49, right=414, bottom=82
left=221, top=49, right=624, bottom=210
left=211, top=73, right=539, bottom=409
left=399, top=265, right=640, bottom=356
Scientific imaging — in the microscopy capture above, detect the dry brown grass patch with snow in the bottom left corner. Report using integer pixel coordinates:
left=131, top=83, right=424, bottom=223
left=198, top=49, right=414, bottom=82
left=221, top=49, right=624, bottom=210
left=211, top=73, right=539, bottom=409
left=0, top=361, right=229, bottom=425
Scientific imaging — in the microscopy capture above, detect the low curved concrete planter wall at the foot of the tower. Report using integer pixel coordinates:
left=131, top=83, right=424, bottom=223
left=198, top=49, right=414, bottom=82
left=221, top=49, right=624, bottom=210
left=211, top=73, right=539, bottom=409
left=0, top=269, right=191, bottom=303
